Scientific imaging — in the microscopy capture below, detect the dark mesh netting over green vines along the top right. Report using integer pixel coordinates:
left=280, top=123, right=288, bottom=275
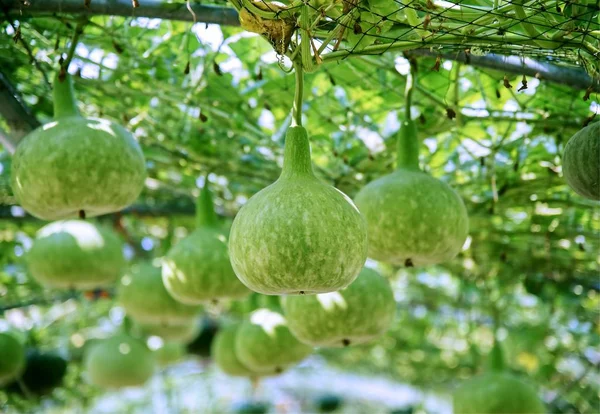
left=227, top=0, right=600, bottom=75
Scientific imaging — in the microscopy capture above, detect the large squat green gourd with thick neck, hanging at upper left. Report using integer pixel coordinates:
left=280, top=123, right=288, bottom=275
left=11, top=75, right=146, bottom=220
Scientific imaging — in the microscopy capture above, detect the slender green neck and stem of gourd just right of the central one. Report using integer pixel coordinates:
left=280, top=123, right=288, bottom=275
left=396, top=60, right=419, bottom=171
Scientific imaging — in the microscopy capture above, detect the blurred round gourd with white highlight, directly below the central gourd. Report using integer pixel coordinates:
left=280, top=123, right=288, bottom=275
left=282, top=268, right=396, bottom=347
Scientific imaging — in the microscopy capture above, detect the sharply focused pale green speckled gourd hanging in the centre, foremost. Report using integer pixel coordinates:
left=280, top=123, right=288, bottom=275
left=229, top=127, right=367, bottom=295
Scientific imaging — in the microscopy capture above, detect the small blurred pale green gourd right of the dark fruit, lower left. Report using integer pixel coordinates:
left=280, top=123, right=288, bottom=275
left=84, top=334, right=155, bottom=388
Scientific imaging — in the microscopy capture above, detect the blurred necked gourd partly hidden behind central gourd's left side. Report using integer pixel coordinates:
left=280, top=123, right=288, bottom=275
left=162, top=176, right=250, bottom=305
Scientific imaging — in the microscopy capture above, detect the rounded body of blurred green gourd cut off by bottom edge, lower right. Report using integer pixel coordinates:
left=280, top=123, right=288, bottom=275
left=453, top=372, right=546, bottom=414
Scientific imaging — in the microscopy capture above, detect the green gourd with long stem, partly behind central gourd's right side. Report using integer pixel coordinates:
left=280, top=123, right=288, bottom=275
left=355, top=63, right=469, bottom=267
